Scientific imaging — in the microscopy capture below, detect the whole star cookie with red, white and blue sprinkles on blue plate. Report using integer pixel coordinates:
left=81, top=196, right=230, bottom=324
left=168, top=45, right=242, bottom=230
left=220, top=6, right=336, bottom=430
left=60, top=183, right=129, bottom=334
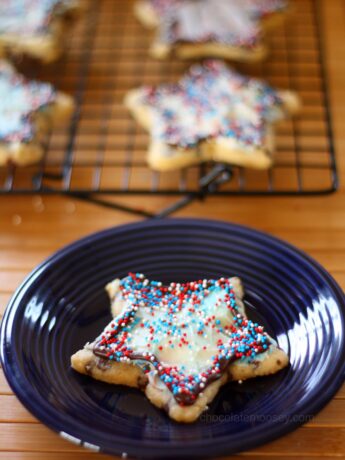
left=71, top=274, right=288, bottom=423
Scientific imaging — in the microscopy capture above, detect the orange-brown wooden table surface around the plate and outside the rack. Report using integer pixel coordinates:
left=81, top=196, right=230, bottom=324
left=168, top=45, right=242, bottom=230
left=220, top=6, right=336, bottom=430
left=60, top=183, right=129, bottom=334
left=0, top=0, right=345, bottom=460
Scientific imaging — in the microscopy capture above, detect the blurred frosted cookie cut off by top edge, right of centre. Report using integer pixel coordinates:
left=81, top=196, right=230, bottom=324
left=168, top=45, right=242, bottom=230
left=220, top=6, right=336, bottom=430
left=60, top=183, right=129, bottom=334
left=135, top=0, right=288, bottom=61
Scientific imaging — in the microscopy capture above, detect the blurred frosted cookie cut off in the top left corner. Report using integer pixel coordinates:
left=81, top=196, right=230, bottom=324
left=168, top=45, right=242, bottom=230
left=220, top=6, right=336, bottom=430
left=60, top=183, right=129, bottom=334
left=0, top=0, right=81, bottom=62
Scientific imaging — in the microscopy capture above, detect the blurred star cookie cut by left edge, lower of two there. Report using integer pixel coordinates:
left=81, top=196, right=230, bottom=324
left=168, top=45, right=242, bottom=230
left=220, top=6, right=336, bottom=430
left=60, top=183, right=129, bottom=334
left=0, top=60, right=74, bottom=165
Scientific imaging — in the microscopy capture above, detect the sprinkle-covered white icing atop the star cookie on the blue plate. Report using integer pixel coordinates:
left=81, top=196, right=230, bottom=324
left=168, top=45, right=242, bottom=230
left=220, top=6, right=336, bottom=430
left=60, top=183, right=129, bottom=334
left=92, top=273, right=271, bottom=404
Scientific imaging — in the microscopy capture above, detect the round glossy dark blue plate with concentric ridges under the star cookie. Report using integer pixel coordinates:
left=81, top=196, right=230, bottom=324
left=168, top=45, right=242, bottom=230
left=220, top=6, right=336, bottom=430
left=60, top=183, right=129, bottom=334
left=1, top=219, right=345, bottom=459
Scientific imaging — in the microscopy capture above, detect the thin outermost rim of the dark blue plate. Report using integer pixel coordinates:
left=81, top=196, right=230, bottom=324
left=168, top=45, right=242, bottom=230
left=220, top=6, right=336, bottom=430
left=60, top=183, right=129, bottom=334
left=0, top=218, right=345, bottom=458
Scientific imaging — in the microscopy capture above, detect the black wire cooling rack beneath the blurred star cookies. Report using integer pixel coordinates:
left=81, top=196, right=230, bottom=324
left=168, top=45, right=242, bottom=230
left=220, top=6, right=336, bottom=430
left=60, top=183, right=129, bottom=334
left=0, top=0, right=338, bottom=216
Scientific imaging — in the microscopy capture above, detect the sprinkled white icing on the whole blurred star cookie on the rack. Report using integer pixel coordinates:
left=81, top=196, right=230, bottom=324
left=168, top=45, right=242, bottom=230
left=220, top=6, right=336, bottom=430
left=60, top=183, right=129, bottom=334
left=143, top=61, right=284, bottom=149
